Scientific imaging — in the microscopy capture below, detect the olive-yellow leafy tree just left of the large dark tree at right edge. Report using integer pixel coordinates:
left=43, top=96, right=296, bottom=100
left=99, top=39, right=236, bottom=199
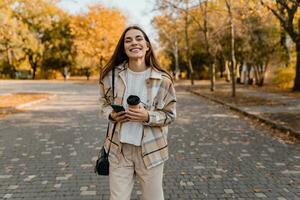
left=242, top=8, right=278, bottom=86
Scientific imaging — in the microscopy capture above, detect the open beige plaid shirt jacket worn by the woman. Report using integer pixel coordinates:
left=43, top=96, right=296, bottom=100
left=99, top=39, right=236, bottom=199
left=99, top=64, right=176, bottom=169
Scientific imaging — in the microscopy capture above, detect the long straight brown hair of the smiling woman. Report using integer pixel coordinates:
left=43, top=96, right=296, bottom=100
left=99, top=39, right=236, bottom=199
left=100, top=25, right=172, bottom=80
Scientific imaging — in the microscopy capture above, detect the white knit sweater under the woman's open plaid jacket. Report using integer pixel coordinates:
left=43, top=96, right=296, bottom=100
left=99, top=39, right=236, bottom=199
left=120, top=68, right=151, bottom=146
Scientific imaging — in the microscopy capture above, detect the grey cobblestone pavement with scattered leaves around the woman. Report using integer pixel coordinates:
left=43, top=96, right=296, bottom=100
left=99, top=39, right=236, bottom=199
left=0, top=82, right=300, bottom=200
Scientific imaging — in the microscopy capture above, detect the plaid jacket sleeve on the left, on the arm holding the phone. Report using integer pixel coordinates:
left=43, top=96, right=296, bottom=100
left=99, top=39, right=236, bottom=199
left=99, top=80, right=114, bottom=122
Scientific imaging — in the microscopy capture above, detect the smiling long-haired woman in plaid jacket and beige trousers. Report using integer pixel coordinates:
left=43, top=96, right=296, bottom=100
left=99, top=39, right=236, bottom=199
left=100, top=26, right=176, bottom=200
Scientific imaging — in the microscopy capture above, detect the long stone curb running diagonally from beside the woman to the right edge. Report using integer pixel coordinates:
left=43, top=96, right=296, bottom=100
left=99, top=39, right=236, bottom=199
left=186, top=88, right=300, bottom=139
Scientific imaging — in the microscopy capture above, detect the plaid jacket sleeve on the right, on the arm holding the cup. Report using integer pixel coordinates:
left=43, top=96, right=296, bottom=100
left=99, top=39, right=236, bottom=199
left=144, top=80, right=176, bottom=126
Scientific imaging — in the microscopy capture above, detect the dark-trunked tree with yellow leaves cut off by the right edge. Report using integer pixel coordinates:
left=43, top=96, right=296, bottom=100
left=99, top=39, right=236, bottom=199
left=260, top=0, right=300, bottom=91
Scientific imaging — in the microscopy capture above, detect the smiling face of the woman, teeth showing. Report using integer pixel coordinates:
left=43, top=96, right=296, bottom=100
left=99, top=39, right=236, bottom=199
left=124, top=29, right=149, bottom=59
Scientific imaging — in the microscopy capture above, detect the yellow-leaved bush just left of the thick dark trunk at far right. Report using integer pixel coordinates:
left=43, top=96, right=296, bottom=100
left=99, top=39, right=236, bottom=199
left=273, top=67, right=295, bottom=88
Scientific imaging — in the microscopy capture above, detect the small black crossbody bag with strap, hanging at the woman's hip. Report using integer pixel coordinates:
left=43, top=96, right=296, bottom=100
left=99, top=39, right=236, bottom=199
left=94, top=68, right=117, bottom=176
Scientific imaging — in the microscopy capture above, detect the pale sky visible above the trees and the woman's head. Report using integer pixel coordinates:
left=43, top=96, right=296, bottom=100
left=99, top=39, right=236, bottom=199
left=59, top=0, right=156, bottom=39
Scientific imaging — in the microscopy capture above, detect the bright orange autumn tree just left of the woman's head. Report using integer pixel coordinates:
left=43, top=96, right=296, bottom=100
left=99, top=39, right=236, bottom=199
left=71, top=4, right=126, bottom=74
